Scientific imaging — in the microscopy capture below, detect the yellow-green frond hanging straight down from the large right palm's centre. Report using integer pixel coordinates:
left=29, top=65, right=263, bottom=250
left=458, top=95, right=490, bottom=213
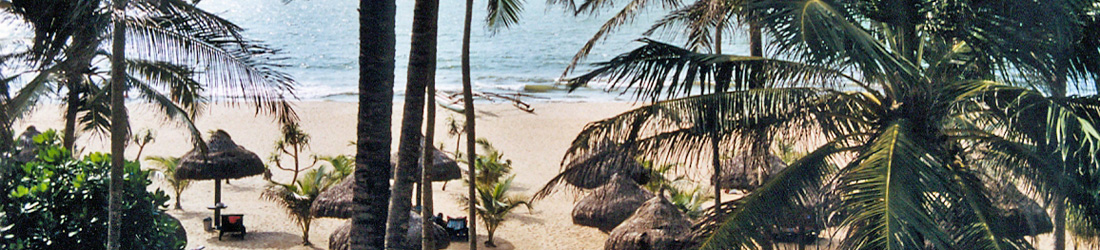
left=839, top=119, right=953, bottom=249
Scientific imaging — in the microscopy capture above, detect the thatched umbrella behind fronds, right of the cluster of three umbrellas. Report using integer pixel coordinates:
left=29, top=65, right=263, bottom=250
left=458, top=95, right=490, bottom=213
left=721, top=152, right=787, bottom=191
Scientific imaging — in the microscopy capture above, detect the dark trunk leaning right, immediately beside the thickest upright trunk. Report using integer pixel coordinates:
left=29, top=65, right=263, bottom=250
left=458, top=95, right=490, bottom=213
left=386, top=0, right=439, bottom=244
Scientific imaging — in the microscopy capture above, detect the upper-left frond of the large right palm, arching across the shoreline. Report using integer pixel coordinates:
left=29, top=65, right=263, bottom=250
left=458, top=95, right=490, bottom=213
left=569, top=40, right=875, bottom=100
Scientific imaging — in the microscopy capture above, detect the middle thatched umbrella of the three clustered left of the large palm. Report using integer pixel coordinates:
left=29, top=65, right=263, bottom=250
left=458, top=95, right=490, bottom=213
left=573, top=175, right=653, bottom=231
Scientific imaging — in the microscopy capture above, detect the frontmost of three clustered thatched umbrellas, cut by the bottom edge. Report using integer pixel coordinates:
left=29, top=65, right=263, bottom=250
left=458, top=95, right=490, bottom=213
left=604, top=191, right=691, bottom=250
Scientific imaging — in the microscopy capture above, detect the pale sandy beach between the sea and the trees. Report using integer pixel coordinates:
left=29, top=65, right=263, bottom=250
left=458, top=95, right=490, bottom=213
left=15, top=101, right=631, bottom=249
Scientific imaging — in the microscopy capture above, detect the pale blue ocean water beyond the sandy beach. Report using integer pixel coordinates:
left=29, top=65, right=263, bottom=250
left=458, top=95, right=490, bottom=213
left=199, top=0, right=744, bottom=102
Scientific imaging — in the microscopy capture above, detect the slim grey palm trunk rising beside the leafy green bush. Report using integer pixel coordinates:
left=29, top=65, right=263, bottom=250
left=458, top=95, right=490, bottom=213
left=106, top=0, right=129, bottom=250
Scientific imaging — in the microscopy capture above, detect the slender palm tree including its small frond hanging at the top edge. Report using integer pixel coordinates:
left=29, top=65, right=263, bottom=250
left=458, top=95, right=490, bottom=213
left=455, top=0, right=524, bottom=246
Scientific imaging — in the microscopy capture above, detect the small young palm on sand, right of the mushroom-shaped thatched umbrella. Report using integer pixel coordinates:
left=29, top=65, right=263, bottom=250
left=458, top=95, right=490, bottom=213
left=261, top=166, right=338, bottom=246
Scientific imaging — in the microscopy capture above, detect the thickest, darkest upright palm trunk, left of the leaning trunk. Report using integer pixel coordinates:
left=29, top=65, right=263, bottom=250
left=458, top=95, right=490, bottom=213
left=349, top=0, right=397, bottom=250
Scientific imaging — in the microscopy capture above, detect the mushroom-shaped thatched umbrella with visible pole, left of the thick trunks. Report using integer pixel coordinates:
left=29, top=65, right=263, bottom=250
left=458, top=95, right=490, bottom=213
left=176, top=130, right=266, bottom=227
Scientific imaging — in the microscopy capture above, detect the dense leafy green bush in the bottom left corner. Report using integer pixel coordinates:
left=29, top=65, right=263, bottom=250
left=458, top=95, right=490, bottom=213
left=0, top=131, right=187, bottom=249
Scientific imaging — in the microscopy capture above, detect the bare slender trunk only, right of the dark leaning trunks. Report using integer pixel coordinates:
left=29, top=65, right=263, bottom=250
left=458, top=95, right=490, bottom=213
left=462, top=0, right=477, bottom=250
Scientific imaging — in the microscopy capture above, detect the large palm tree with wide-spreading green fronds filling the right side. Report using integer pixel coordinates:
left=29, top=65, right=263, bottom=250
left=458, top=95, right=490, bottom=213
left=550, top=1, right=1100, bottom=249
